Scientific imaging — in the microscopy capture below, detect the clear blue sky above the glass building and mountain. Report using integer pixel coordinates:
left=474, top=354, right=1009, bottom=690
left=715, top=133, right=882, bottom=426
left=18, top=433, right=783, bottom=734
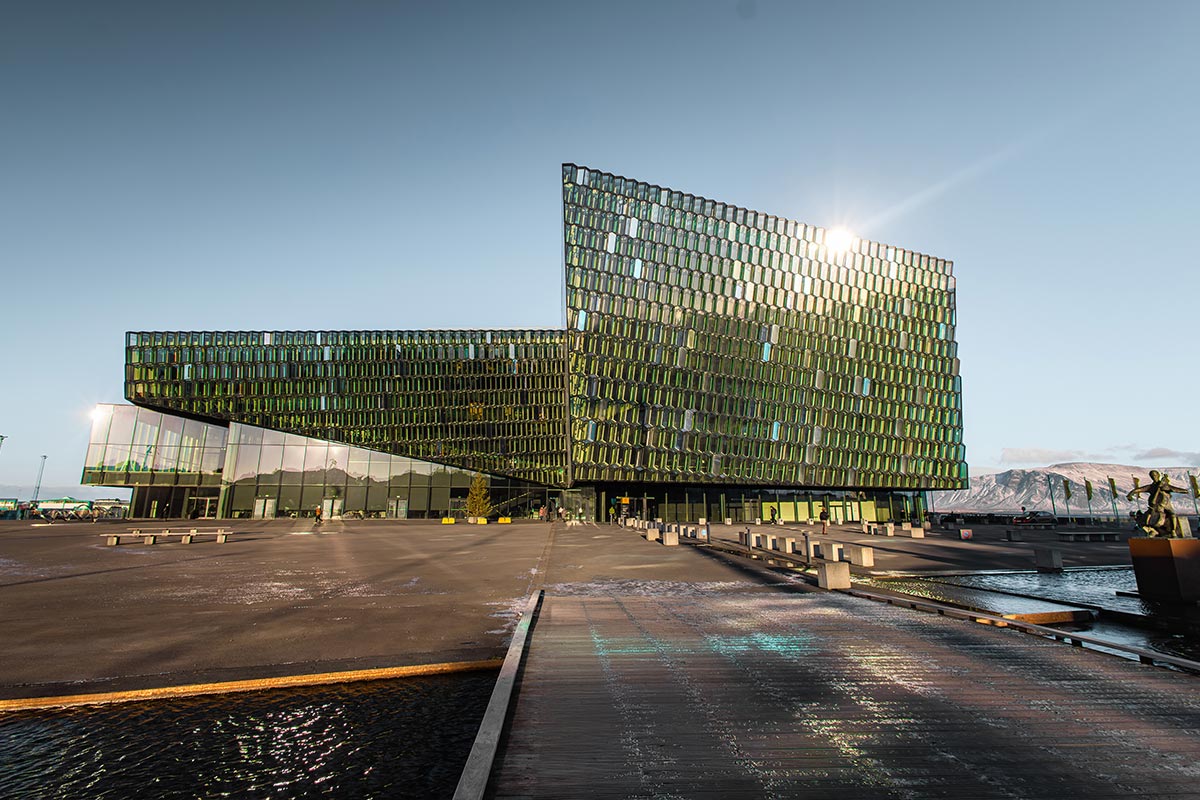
left=0, top=0, right=1200, bottom=486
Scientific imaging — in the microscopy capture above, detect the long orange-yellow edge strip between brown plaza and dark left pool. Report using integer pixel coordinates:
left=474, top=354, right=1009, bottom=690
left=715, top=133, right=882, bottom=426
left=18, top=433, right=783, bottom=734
left=0, top=658, right=504, bottom=711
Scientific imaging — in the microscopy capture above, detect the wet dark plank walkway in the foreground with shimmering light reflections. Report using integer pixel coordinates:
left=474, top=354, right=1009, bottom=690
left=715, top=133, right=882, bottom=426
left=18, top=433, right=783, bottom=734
left=491, top=590, right=1200, bottom=800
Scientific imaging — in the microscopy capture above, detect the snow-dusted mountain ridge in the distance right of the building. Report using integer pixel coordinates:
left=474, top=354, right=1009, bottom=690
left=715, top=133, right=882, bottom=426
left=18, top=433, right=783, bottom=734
left=934, top=462, right=1200, bottom=516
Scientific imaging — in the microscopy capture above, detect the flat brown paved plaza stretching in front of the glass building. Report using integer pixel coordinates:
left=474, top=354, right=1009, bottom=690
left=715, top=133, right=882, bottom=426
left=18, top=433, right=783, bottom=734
left=0, top=519, right=1128, bottom=699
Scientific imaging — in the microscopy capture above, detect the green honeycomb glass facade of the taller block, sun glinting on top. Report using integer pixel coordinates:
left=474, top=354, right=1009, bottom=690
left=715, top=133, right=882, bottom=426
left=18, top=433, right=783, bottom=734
left=563, top=164, right=967, bottom=489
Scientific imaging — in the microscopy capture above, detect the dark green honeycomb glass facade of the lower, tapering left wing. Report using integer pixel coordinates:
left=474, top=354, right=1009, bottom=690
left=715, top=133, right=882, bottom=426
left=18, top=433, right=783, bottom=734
left=125, top=330, right=568, bottom=486
